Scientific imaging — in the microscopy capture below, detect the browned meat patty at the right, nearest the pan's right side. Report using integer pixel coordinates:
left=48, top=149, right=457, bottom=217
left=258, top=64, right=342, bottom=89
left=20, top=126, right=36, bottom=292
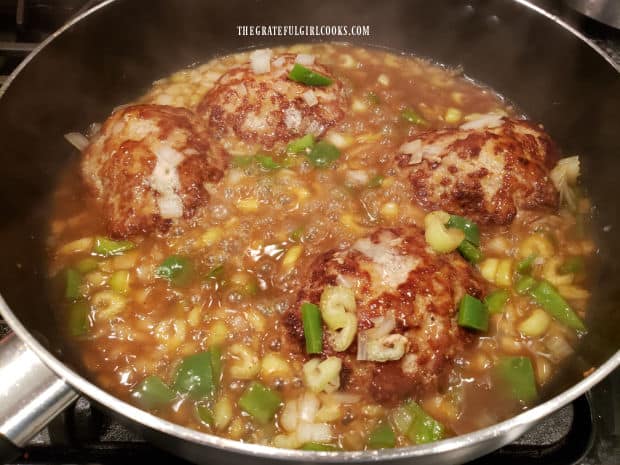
left=397, top=116, right=559, bottom=225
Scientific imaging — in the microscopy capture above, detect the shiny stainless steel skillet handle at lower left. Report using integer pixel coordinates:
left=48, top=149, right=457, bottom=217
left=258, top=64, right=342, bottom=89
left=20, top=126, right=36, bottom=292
left=0, top=333, right=78, bottom=463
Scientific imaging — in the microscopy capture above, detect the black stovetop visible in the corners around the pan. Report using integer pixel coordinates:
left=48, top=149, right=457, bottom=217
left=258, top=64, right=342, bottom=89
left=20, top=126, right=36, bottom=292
left=0, top=0, right=620, bottom=465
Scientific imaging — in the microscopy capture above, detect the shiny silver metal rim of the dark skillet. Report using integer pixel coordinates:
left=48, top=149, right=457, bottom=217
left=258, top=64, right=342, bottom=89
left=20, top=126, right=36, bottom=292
left=0, top=0, right=620, bottom=463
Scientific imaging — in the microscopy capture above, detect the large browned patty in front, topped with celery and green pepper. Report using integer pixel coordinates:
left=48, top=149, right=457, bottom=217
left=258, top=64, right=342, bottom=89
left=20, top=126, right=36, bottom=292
left=284, top=227, right=485, bottom=401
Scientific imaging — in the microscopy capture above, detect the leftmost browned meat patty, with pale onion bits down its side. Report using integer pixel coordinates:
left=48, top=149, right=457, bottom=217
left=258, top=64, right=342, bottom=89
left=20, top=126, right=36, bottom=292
left=81, top=105, right=224, bottom=238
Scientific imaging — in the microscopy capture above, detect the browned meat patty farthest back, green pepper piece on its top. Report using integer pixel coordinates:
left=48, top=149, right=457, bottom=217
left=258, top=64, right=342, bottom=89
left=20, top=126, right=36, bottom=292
left=197, top=54, right=346, bottom=152
